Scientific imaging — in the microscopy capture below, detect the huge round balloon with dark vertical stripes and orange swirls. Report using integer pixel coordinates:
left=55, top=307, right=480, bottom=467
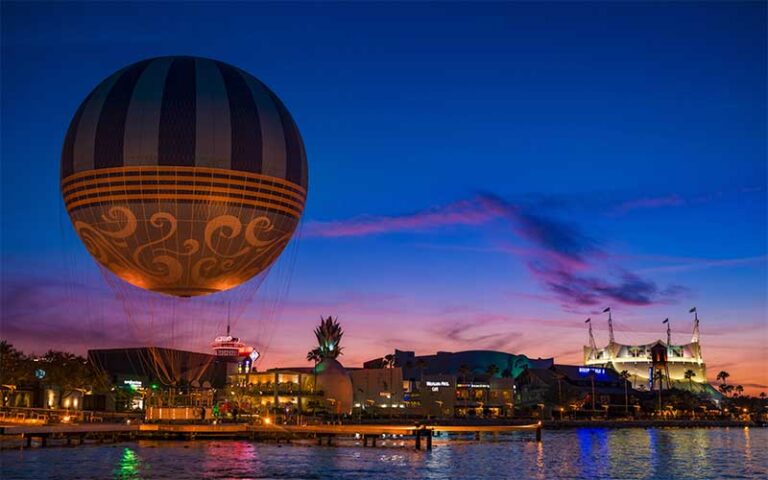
left=61, top=56, right=307, bottom=297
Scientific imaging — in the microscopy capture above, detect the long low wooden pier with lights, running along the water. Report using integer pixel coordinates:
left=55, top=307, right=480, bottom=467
left=0, top=422, right=542, bottom=450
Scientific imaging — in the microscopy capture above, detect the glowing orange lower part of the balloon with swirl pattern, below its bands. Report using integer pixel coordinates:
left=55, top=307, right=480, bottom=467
left=67, top=168, right=303, bottom=296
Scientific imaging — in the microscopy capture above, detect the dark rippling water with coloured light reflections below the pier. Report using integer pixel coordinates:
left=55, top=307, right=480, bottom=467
left=0, top=428, right=768, bottom=480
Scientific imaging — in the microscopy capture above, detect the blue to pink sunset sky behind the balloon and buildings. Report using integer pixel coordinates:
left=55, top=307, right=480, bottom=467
left=0, top=2, right=768, bottom=392
